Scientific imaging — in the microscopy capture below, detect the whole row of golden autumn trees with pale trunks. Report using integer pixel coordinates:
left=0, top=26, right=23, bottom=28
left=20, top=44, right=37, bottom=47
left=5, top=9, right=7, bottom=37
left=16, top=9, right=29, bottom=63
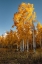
left=0, top=3, right=42, bottom=52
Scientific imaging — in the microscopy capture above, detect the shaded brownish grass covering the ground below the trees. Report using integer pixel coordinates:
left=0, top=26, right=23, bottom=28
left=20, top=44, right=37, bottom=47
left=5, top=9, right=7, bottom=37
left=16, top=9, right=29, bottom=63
left=0, top=48, right=42, bottom=64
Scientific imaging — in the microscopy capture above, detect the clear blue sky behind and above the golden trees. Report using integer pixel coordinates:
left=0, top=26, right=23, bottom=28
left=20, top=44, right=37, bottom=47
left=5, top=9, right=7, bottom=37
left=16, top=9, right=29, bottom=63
left=0, top=0, right=42, bottom=35
